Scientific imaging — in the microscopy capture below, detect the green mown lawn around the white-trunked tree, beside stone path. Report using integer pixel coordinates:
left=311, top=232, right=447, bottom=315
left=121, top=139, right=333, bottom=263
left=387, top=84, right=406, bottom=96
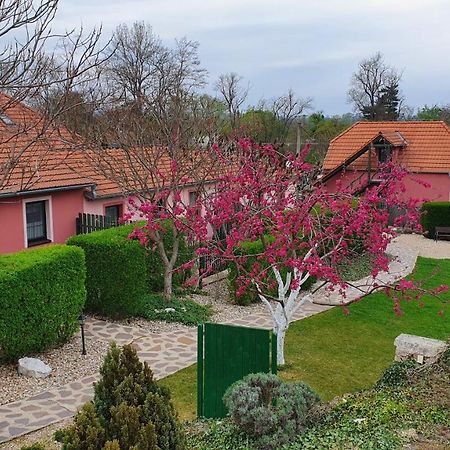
left=161, top=258, right=450, bottom=419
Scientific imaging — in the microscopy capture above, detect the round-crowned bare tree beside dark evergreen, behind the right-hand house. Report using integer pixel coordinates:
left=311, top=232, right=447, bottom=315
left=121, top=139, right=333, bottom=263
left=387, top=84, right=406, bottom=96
left=347, top=52, right=402, bottom=120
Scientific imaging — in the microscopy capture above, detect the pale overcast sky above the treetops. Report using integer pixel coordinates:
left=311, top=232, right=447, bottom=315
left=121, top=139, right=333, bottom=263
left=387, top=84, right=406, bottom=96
left=54, top=0, right=450, bottom=115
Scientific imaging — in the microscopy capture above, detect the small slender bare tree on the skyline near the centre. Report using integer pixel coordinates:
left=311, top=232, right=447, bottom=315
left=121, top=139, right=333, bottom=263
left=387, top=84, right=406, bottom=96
left=215, top=72, right=250, bottom=129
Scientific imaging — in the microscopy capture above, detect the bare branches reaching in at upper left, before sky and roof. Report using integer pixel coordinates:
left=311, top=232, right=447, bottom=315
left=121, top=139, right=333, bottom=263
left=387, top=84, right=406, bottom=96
left=0, top=0, right=104, bottom=191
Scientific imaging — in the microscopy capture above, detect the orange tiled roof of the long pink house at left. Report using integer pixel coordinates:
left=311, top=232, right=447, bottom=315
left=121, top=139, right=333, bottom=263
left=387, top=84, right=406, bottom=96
left=0, top=93, right=220, bottom=197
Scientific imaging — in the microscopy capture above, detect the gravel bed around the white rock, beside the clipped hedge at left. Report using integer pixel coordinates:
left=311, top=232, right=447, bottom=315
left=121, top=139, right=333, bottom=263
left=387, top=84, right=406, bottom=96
left=0, top=334, right=108, bottom=405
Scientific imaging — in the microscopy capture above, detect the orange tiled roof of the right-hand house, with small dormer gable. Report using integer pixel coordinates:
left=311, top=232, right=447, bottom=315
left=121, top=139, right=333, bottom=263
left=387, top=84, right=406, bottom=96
left=323, top=121, right=450, bottom=173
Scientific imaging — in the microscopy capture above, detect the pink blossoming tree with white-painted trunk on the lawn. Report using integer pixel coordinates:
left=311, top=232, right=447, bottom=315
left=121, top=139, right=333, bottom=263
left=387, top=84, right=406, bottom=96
left=201, top=140, right=442, bottom=364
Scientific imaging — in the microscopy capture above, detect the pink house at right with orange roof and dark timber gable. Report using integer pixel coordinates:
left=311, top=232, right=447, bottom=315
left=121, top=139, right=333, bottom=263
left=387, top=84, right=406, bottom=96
left=322, top=121, right=450, bottom=201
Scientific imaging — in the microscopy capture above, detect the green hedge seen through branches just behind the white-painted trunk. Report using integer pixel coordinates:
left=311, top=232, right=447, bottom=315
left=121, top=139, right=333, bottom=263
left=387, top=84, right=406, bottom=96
left=228, top=236, right=315, bottom=305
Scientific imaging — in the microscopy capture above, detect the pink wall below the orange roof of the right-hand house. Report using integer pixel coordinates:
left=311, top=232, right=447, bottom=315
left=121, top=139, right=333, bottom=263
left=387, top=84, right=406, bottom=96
left=326, top=171, right=450, bottom=201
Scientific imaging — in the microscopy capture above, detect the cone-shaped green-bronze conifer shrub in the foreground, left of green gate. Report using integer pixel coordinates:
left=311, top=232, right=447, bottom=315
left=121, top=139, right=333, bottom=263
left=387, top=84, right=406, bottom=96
left=55, top=344, right=186, bottom=450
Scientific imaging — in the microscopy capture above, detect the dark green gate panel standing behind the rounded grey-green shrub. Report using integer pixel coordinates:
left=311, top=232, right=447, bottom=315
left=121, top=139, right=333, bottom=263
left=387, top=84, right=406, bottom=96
left=197, top=323, right=277, bottom=418
